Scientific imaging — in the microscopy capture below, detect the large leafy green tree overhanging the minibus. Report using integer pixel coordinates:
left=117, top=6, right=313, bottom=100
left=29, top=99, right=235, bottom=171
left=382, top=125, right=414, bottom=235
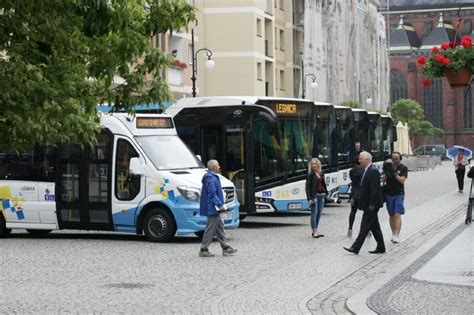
left=0, top=0, right=195, bottom=151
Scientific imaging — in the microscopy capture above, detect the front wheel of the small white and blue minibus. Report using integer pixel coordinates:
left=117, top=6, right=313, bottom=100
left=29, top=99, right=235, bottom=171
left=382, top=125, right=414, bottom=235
left=143, top=209, right=176, bottom=242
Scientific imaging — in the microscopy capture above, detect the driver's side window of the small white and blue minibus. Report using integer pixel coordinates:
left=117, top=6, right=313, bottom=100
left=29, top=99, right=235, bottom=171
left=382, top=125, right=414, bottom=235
left=115, top=139, right=140, bottom=200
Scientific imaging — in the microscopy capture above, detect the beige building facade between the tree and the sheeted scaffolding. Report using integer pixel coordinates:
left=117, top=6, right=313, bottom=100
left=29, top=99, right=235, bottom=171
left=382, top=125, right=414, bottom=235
left=184, top=0, right=296, bottom=97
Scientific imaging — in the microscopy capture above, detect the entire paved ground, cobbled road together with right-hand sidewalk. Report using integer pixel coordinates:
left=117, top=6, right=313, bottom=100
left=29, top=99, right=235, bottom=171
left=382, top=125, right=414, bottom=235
left=0, top=161, right=474, bottom=314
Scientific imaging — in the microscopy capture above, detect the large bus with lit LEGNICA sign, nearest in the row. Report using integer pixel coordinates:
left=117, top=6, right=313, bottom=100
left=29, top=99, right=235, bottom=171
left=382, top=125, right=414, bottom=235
left=167, top=97, right=338, bottom=216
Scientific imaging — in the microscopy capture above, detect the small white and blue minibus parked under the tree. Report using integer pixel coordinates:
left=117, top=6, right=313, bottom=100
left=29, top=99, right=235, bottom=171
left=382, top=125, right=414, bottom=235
left=0, top=113, right=239, bottom=242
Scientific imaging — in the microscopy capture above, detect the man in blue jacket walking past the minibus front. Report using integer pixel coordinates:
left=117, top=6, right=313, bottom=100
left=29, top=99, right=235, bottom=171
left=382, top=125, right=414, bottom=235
left=199, top=160, right=237, bottom=257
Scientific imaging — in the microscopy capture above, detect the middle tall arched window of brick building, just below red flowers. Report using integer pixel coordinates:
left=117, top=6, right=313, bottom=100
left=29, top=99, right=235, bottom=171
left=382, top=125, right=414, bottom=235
left=423, top=78, right=444, bottom=129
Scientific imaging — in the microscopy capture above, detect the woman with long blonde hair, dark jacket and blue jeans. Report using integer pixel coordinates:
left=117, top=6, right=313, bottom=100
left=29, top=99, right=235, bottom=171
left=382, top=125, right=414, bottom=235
left=306, top=158, right=328, bottom=238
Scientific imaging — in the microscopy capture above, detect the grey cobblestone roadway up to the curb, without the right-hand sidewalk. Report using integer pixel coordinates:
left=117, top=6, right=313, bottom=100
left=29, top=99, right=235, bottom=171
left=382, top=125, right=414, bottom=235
left=0, top=162, right=467, bottom=314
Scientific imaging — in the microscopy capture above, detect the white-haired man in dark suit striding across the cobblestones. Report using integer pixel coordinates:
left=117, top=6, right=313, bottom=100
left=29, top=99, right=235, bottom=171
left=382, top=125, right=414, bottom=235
left=344, top=151, right=385, bottom=254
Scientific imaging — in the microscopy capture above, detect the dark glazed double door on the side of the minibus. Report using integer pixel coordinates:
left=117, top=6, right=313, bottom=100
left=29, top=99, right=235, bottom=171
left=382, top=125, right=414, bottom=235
left=56, top=131, right=113, bottom=230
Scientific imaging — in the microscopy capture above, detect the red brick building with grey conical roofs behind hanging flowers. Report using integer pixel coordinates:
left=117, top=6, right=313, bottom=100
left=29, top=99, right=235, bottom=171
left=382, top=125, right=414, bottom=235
left=384, top=3, right=474, bottom=148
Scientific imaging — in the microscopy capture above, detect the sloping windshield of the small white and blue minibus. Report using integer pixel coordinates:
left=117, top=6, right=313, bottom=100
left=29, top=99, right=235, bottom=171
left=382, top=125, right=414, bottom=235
left=135, top=136, right=204, bottom=170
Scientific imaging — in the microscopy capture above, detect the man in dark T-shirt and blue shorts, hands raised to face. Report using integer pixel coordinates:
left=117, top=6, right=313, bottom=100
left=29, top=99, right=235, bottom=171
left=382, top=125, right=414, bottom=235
left=382, top=152, right=408, bottom=243
